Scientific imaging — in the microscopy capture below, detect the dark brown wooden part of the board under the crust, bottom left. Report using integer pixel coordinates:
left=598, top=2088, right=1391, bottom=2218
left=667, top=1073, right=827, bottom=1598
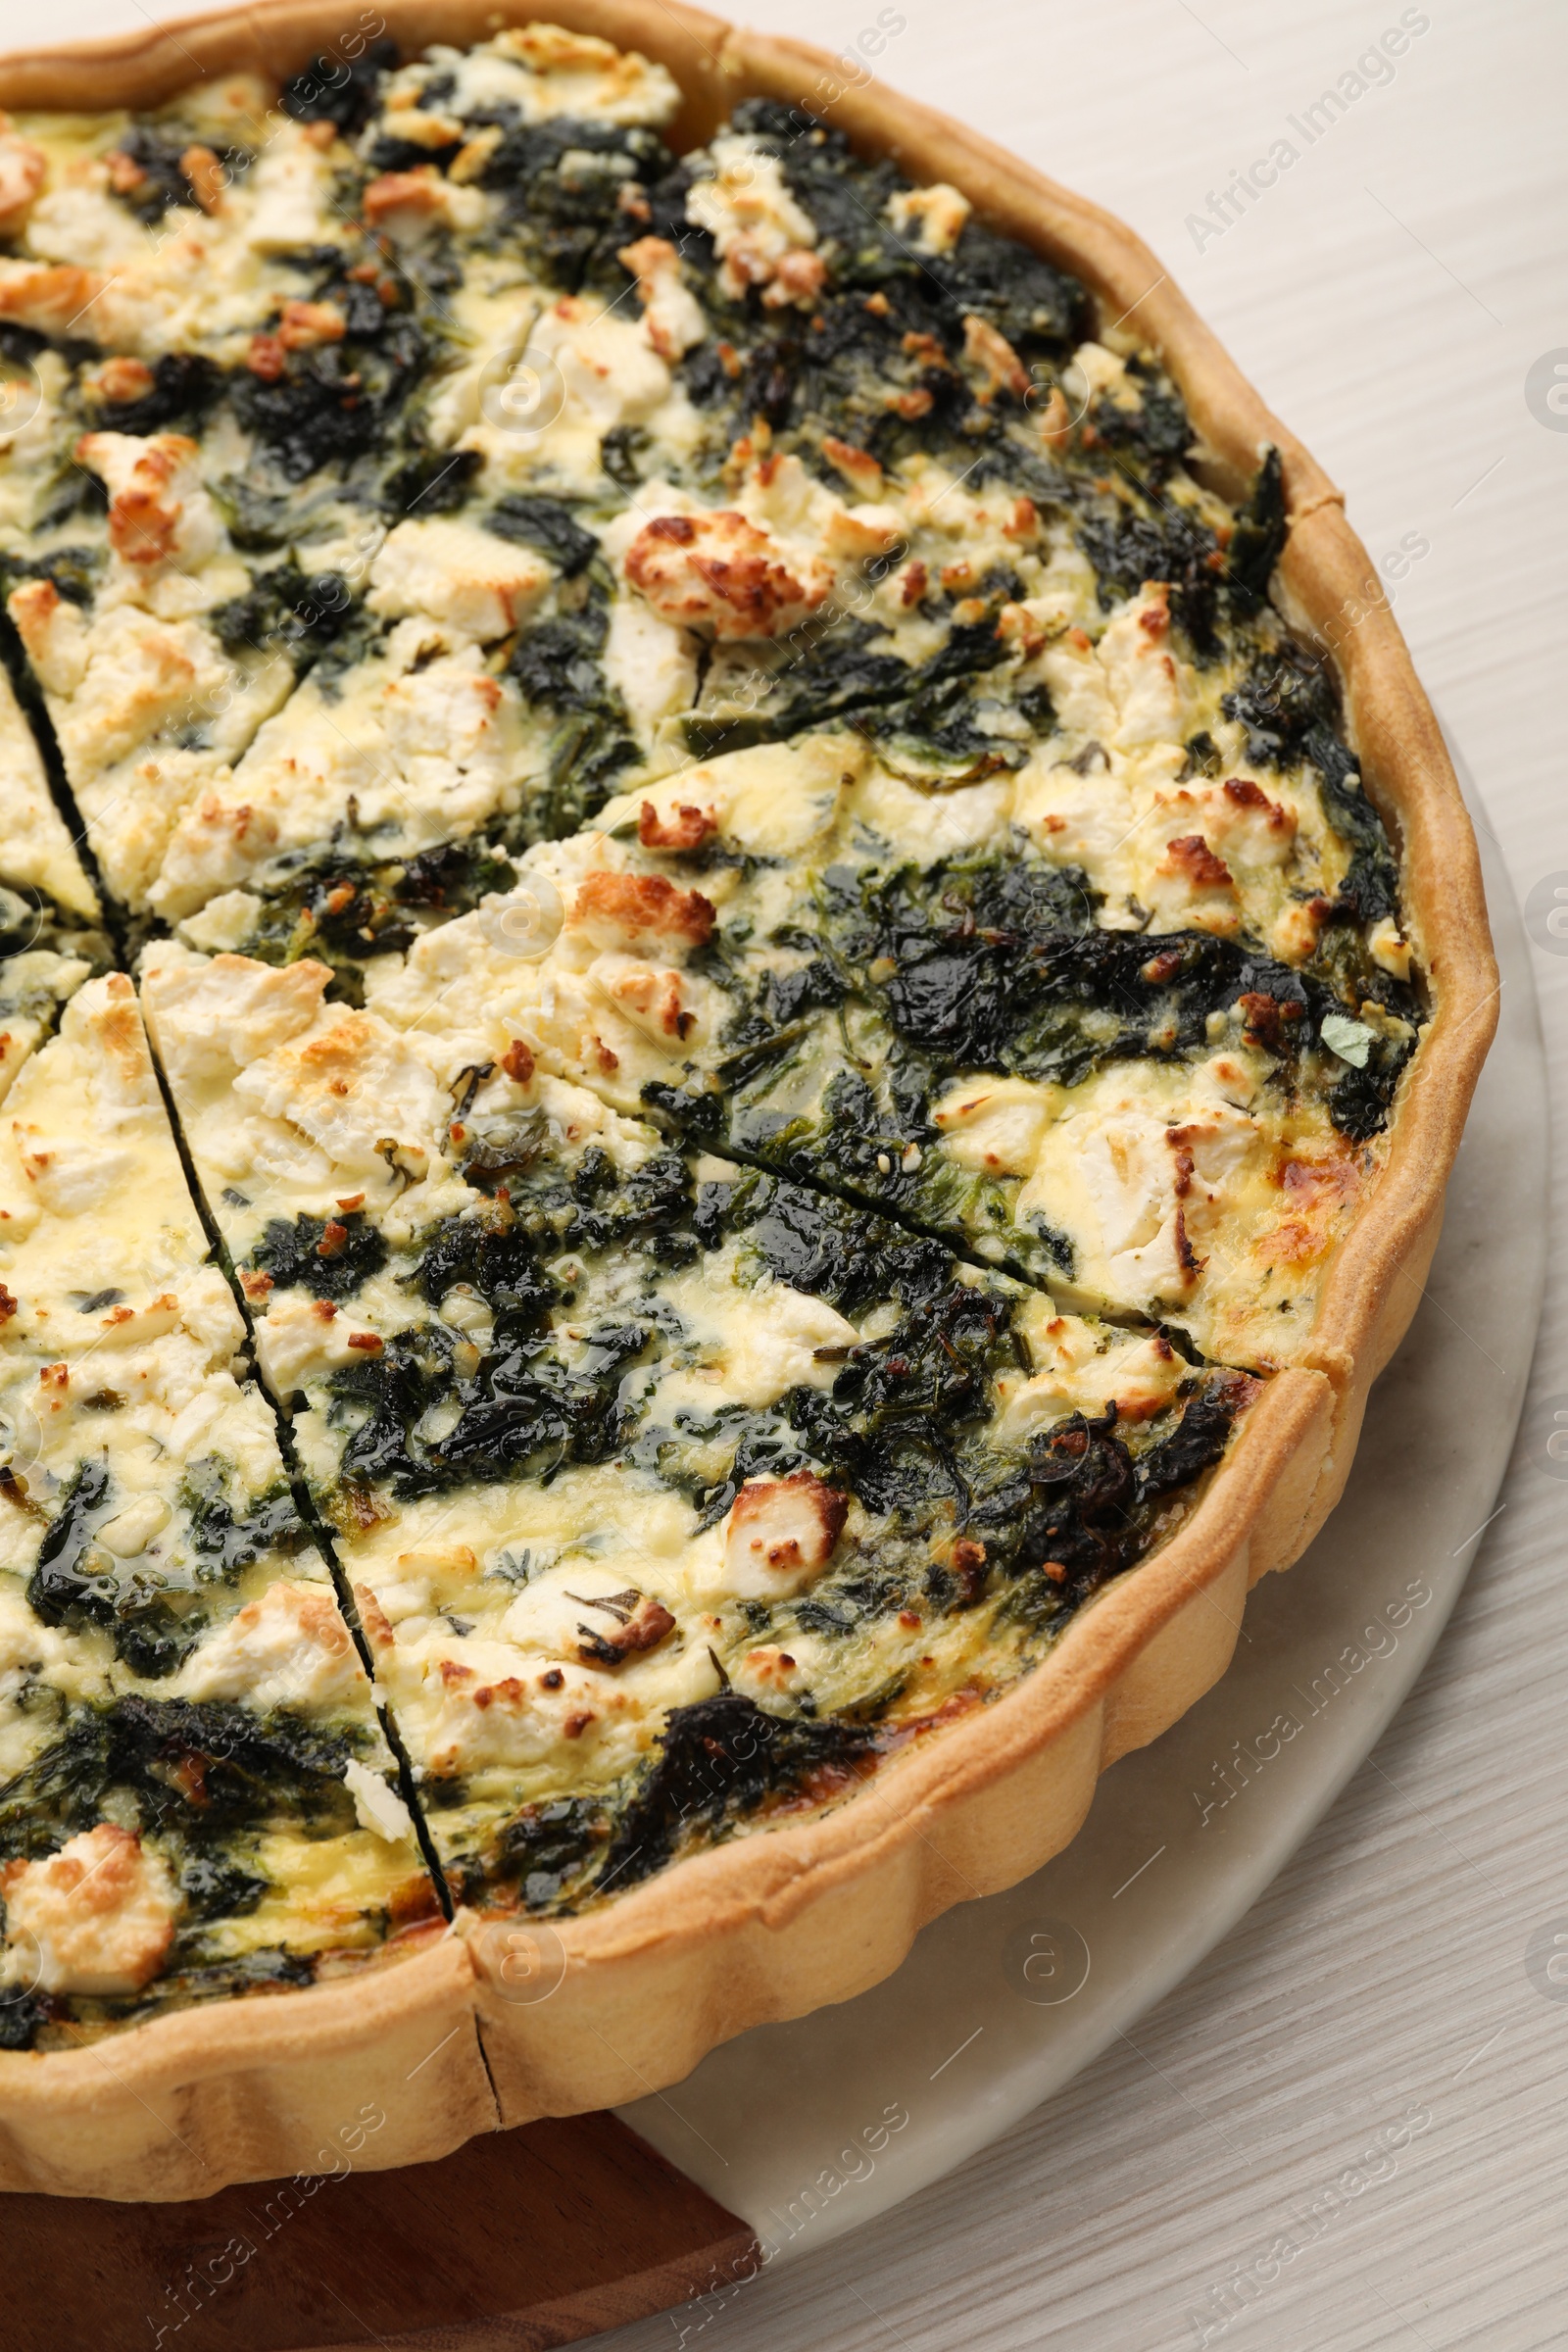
left=0, top=2115, right=755, bottom=2352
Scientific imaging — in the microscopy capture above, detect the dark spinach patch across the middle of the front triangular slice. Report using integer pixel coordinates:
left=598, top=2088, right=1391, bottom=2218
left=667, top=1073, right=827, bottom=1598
left=305, top=1131, right=1241, bottom=1531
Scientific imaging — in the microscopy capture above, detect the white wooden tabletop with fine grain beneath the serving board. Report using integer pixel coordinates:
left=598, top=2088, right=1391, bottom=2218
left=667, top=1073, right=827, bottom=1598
left=30, top=0, right=1568, bottom=2352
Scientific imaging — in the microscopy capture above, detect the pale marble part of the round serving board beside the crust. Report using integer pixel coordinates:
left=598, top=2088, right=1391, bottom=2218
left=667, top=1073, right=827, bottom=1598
left=620, top=748, right=1546, bottom=2258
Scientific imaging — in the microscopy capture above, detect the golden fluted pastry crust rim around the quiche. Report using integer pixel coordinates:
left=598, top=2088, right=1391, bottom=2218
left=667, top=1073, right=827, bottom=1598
left=0, top=0, right=1497, bottom=2199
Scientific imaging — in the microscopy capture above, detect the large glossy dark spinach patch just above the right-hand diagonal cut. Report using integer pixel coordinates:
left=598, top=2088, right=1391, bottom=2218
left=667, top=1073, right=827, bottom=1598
left=644, top=816, right=1420, bottom=1272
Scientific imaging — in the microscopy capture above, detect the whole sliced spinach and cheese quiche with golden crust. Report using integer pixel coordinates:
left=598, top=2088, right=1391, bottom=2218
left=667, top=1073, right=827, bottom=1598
left=0, top=0, right=1495, bottom=2197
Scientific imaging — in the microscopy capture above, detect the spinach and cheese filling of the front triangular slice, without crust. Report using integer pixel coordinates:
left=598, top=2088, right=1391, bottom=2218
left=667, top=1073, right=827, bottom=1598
left=143, top=946, right=1255, bottom=1907
